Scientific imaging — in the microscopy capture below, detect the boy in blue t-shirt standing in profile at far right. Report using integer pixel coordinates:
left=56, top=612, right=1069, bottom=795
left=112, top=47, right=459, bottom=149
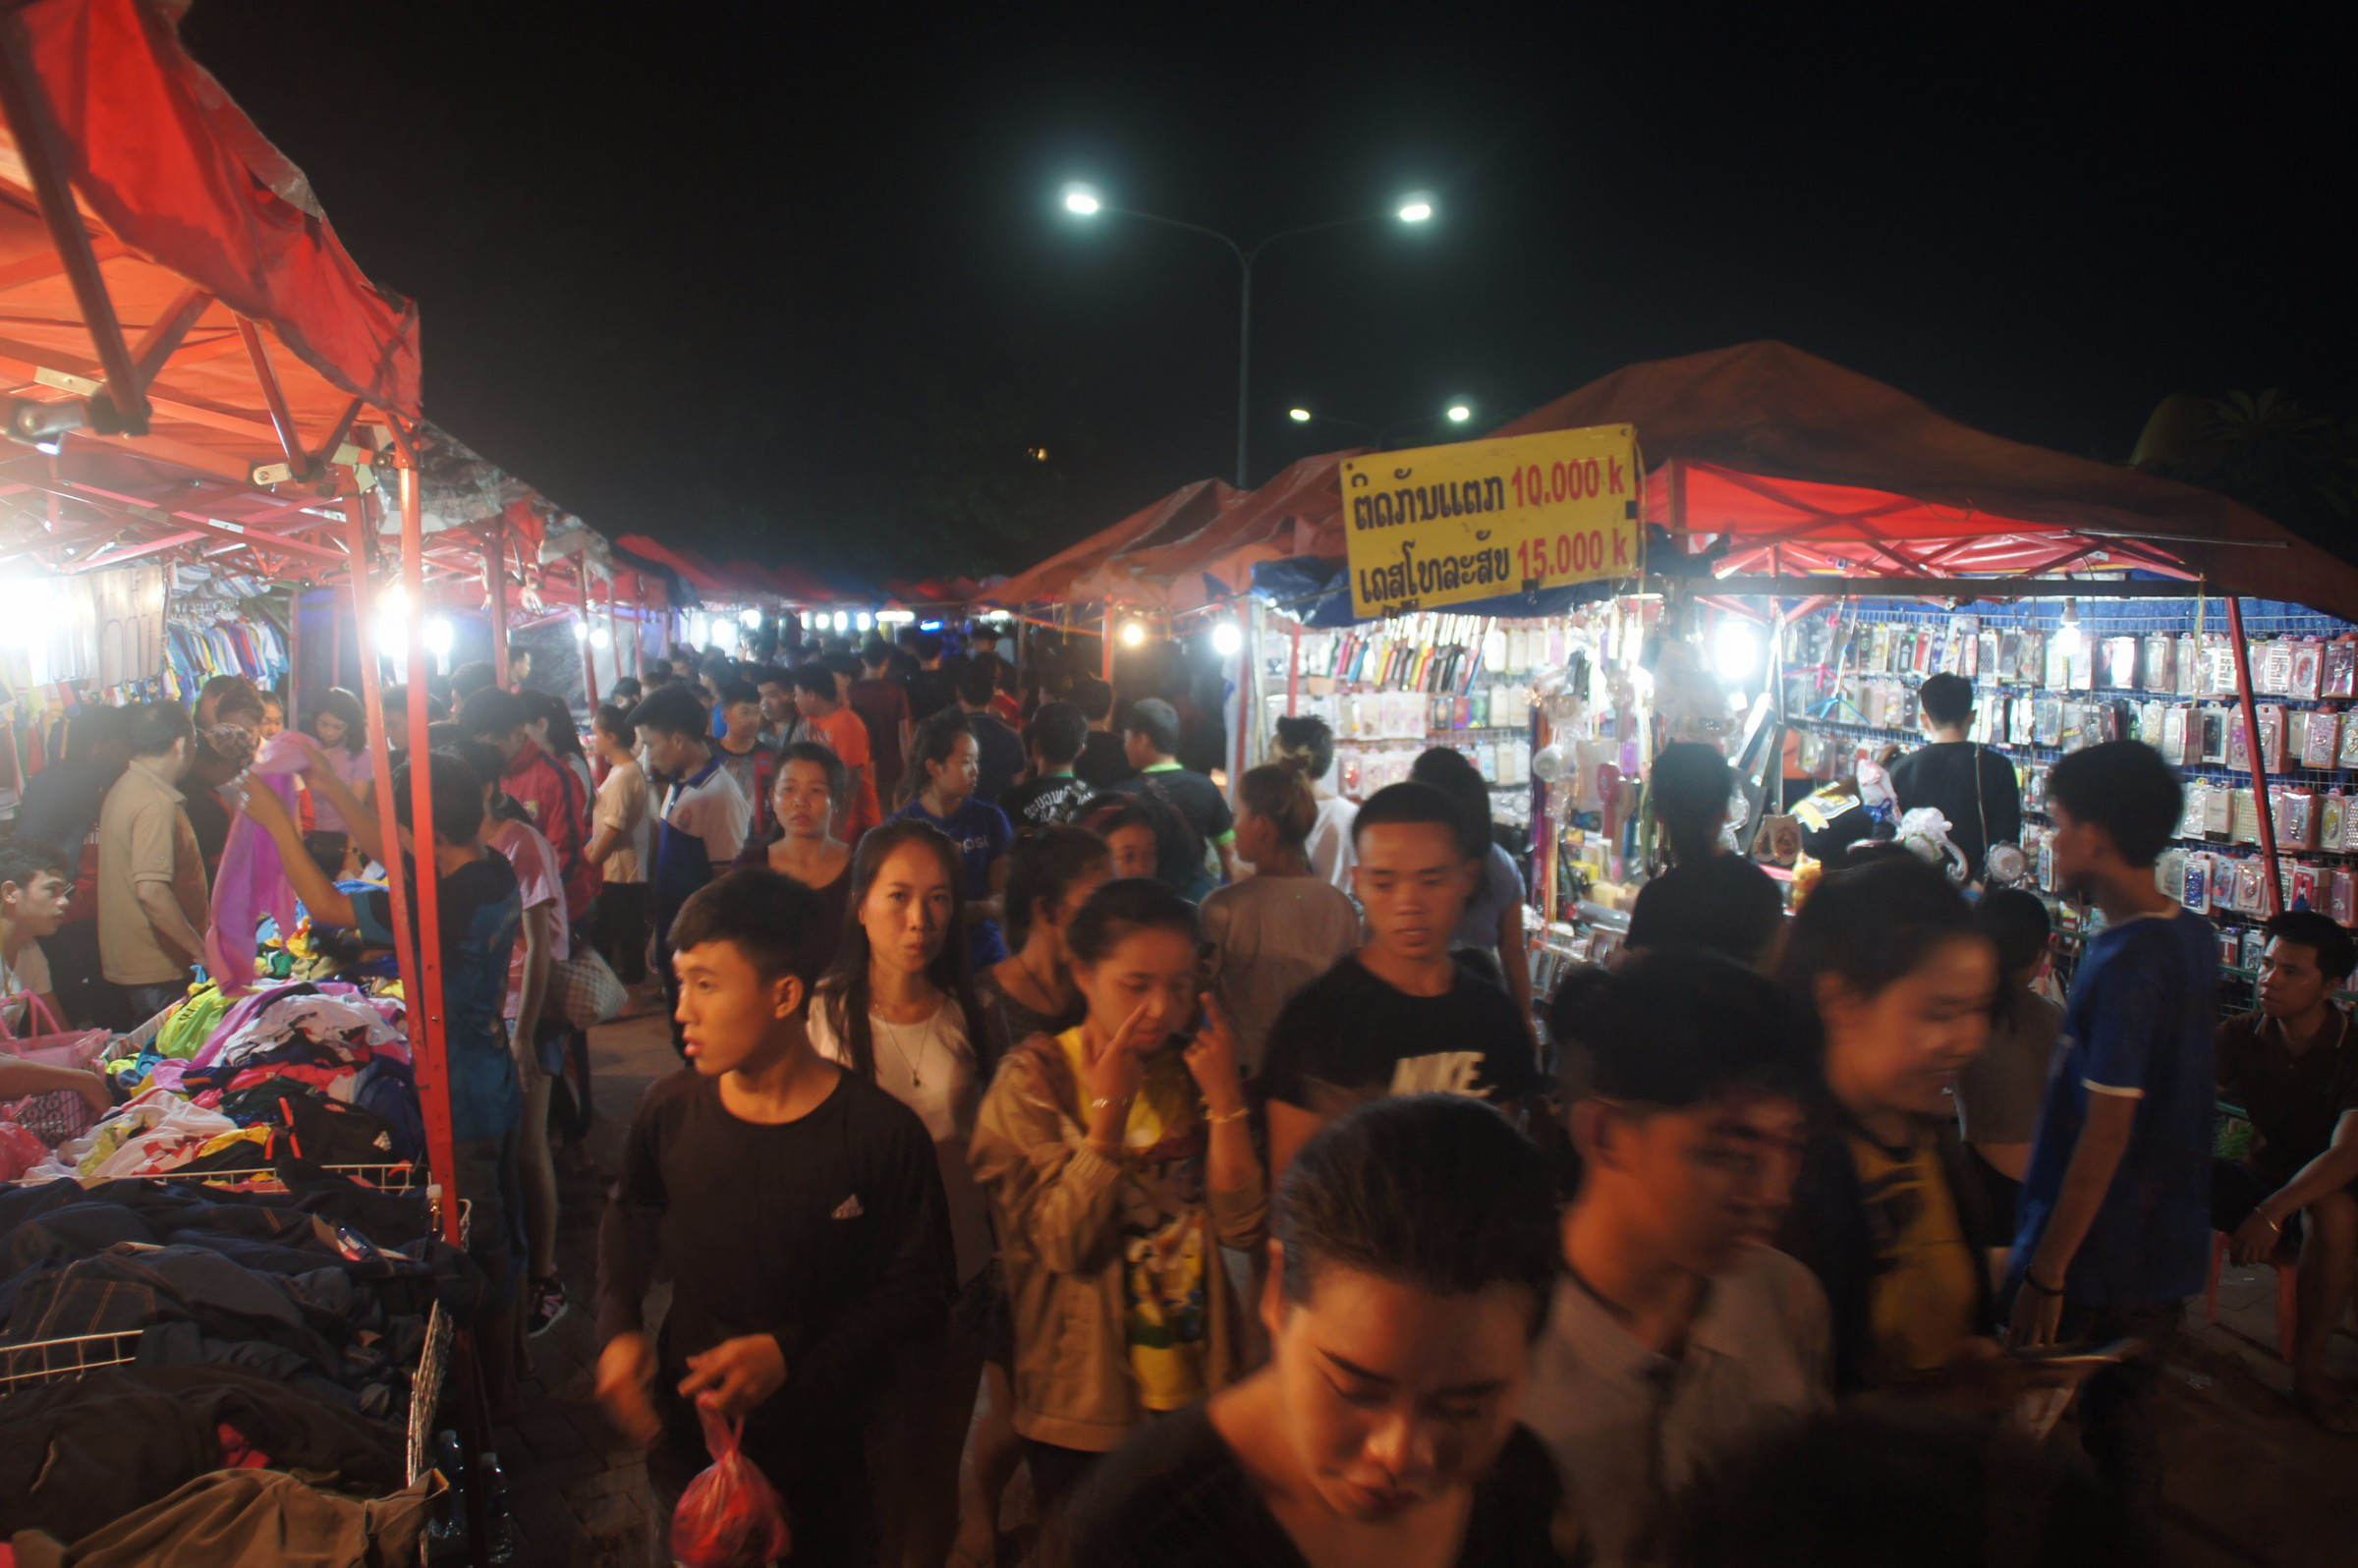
left=2009, top=741, right=2218, bottom=1519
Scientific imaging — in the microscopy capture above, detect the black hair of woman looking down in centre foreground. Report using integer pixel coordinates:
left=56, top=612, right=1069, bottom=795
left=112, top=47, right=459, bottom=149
left=1268, top=1094, right=1563, bottom=1334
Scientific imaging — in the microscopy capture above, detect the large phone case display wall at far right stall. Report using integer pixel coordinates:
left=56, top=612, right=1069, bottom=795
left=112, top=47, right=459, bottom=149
left=1785, top=599, right=2358, bottom=1004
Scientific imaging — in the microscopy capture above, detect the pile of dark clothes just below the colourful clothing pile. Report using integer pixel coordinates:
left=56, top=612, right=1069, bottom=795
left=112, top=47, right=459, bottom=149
left=0, top=1169, right=483, bottom=1422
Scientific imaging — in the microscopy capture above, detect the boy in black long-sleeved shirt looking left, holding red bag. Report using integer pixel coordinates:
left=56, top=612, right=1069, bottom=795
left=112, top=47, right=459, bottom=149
left=596, top=868, right=953, bottom=1566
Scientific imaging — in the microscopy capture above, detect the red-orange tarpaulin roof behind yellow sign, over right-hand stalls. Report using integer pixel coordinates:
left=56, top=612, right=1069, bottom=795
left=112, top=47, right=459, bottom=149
left=1056, top=342, right=2358, bottom=620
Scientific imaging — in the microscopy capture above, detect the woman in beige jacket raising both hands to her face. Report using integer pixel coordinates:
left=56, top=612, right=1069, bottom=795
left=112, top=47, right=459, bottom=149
left=974, top=879, right=1268, bottom=1514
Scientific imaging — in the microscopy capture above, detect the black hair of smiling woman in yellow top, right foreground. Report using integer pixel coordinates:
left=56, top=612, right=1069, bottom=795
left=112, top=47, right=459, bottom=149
left=1782, top=854, right=1988, bottom=1019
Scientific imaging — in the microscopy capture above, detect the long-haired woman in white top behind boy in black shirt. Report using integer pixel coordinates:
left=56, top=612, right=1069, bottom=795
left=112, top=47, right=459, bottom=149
left=812, top=818, right=992, bottom=1568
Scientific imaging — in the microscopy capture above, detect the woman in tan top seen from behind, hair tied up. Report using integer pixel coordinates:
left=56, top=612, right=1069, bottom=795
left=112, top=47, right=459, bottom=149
left=1203, top=756, right=1358, bottom=1075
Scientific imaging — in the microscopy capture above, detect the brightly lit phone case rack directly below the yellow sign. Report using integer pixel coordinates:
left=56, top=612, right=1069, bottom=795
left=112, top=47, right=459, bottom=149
left=1287, top=613, right=1566, bottom=827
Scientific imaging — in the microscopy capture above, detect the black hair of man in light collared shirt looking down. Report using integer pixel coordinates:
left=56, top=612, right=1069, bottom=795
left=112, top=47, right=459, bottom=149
left=1546, top=948, right=1809, bottom=1110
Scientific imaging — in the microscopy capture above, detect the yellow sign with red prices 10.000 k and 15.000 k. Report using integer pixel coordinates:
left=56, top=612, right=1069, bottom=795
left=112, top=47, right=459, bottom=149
left=1342, top=424, right=1644, bottom=620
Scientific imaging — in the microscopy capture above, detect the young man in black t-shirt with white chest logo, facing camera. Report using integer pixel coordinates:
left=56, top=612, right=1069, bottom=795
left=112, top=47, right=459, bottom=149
left=1262, top=783, right=1543, bottom=1184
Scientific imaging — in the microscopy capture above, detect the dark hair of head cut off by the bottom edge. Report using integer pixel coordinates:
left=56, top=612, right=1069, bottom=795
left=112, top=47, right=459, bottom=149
left=1664, top=1401, right=2160, bottom=1568
